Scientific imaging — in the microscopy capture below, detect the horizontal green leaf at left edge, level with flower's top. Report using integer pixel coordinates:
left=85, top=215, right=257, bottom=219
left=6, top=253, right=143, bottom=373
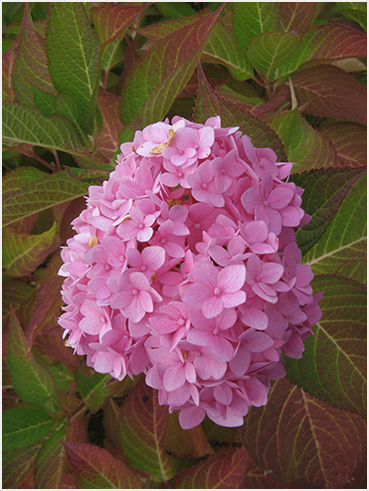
left=3, top=102, right=80, bottom=151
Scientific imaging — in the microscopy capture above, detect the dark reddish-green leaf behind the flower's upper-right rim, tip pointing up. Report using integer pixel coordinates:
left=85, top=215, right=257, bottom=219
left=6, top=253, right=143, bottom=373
left=195, top=62, right=287, bottom=162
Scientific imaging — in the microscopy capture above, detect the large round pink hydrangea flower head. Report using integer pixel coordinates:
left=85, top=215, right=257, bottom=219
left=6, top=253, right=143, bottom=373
left=59, top=116, right=322, bottom=428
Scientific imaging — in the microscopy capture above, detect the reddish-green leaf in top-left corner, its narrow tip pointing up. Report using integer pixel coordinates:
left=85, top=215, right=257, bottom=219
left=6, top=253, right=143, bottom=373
left=13, top=4, right=56, bottom=105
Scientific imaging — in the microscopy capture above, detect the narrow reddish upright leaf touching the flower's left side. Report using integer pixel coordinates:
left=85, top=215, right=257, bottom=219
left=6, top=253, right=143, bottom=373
left=26, top=251, right=63, bottom=349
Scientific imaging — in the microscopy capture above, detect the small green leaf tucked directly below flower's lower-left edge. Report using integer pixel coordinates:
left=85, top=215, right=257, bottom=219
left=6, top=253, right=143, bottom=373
left=76, top=369, right=118, bottom=413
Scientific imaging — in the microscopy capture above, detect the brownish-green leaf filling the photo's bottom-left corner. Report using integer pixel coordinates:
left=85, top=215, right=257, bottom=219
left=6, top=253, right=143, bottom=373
left=2, top=438, right=46, bottom=489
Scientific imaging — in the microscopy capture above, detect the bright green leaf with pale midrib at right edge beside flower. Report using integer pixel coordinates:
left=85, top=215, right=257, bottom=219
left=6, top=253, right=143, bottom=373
left=304, top=176, right=367, bottom=284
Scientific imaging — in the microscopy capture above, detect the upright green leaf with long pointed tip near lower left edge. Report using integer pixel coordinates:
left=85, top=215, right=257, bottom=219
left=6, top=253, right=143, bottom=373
left=8, top=309, right=56, bottom=412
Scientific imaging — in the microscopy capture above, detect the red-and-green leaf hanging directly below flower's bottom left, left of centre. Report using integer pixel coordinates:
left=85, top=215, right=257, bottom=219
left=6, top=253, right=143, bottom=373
left=118, top=378, right=178, bottom=482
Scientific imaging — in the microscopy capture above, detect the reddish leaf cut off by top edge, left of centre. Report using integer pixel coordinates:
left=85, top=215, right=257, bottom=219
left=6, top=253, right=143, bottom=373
left=92, top=2, right=149, bottom=48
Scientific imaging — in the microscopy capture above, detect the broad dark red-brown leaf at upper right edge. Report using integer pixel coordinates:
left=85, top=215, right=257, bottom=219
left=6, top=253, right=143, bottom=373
left=291, top=65, right=366, bottom=124
